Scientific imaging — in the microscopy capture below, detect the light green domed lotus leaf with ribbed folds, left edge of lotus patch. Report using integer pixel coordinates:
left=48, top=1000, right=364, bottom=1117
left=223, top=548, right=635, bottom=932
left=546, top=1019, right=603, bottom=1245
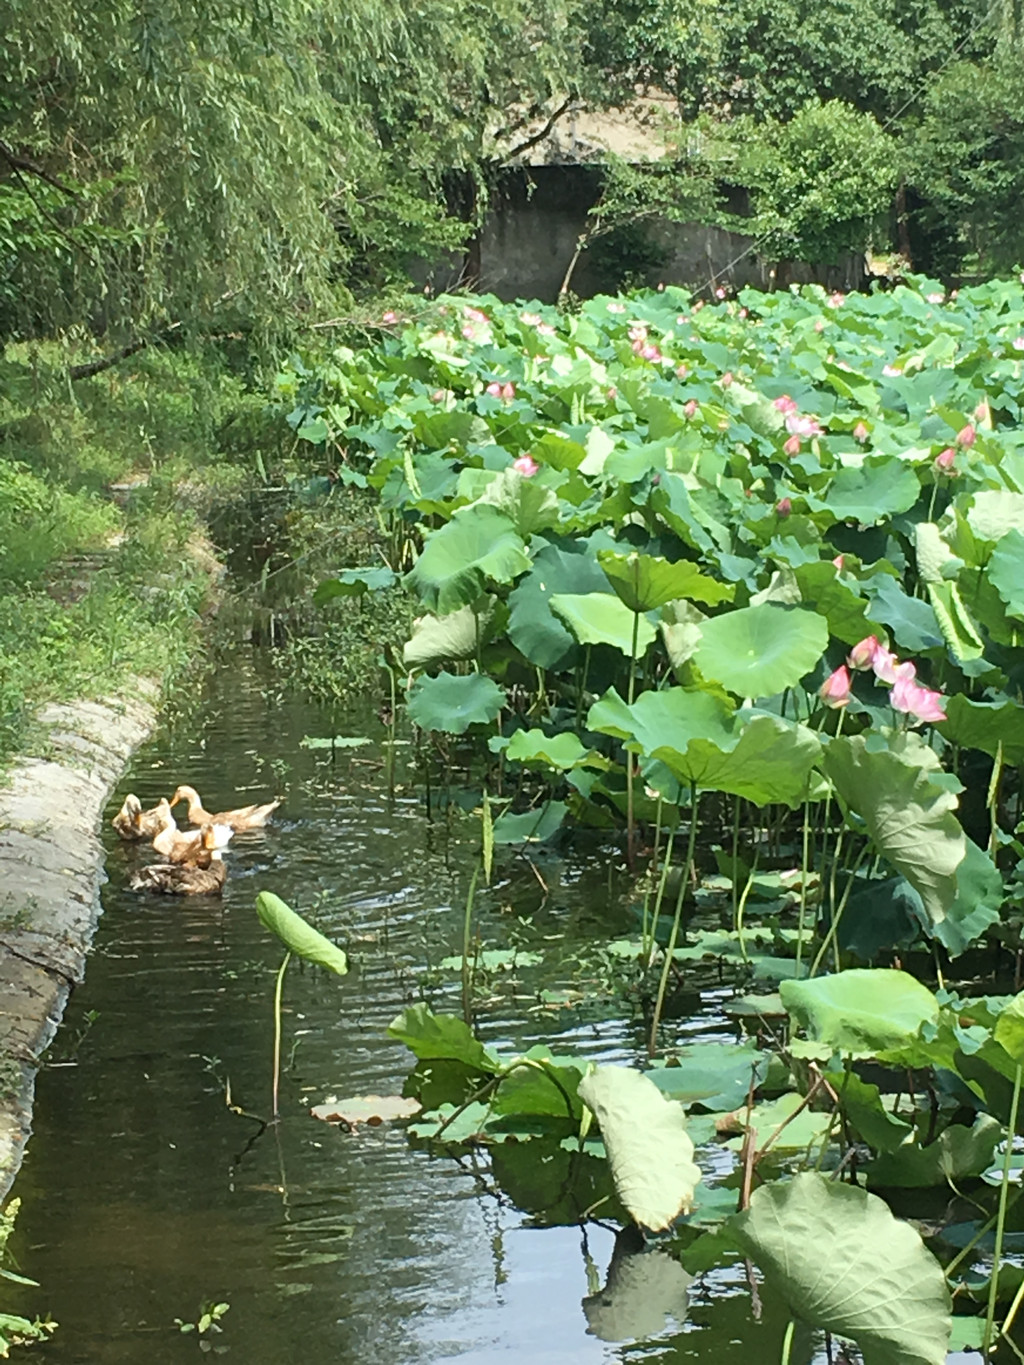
left=406, top=504, right=530, bottom=616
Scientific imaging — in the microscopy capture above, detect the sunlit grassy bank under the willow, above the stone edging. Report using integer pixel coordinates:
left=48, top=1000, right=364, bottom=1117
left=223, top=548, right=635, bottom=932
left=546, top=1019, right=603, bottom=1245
left=0, top=343, right=286, bottom=763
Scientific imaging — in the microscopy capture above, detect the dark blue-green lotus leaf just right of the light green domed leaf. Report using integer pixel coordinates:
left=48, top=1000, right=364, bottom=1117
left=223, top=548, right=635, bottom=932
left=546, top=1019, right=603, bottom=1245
left=508, top=543, right=612, bottom=669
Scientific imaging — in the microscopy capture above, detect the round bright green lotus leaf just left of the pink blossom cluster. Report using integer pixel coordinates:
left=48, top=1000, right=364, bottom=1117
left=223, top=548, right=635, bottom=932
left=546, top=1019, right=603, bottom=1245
left=694, top=602, right=829, bottom=698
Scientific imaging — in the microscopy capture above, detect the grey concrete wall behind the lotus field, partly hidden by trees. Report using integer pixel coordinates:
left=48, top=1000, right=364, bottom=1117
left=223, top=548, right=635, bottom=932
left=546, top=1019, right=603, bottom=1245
left=419, top=165, right=864, bottom=303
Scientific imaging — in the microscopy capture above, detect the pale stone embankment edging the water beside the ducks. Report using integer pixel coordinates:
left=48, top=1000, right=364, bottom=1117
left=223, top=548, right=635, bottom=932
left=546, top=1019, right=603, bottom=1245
left=0, top=685, right=158, bottom=1200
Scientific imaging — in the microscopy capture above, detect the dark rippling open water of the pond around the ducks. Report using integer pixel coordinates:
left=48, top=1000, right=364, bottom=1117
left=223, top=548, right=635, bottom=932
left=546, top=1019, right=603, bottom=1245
left=8, top=644, right=965, bottom=1365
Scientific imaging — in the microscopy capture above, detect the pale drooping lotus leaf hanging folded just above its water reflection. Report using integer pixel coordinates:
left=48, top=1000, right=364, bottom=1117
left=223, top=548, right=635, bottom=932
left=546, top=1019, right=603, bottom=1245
left=579, top=1066, right=700, bottom=1233
